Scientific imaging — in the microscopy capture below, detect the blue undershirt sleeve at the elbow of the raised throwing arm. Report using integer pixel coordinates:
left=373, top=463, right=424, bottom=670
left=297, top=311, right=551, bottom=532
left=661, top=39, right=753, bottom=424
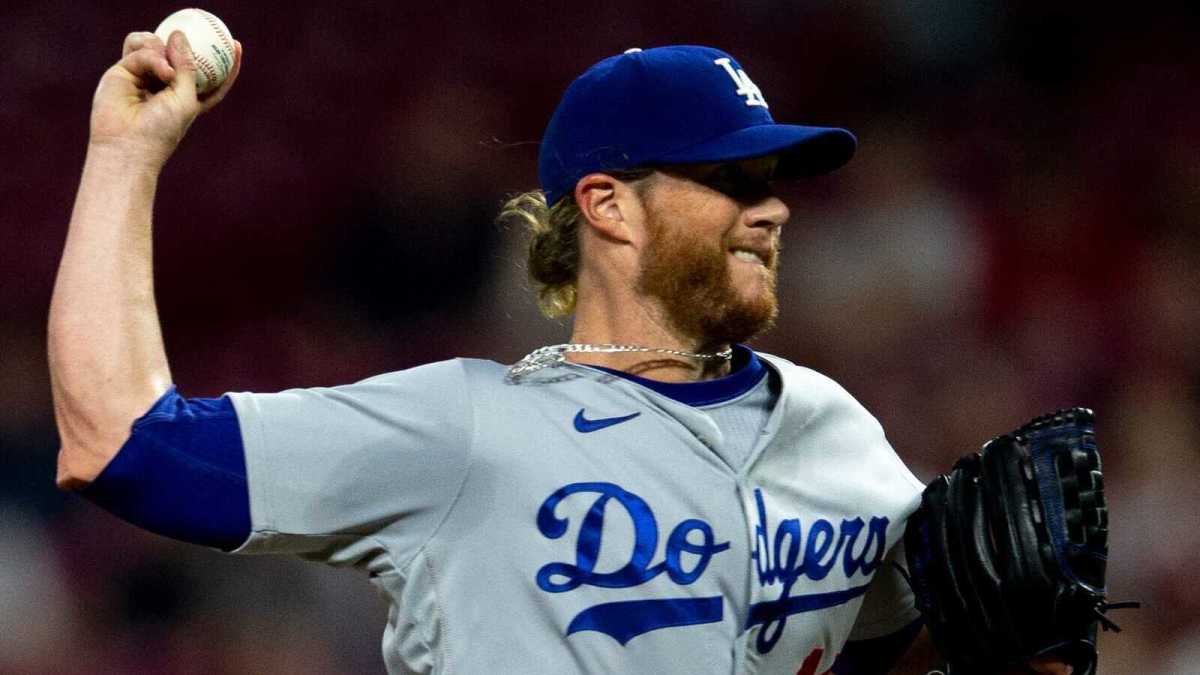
left=82, top=386, right=251, bottom=551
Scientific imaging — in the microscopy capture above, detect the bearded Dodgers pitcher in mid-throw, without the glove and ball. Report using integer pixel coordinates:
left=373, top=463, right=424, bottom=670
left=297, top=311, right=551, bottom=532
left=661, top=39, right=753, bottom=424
left=49, top=32, right=1063, bottom=675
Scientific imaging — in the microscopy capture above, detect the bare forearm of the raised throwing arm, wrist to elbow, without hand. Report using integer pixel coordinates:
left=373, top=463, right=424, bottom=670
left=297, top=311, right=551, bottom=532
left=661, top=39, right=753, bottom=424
left=48, top=145, right=170, bottom=488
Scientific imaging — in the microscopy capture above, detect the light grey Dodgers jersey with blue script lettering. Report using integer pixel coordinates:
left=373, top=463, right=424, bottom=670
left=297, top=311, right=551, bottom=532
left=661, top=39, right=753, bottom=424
left=230, top=354, right=923, bottom=675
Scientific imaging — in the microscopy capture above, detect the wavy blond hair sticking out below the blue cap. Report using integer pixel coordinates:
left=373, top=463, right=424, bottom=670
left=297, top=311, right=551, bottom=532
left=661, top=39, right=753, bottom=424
left=496, top=168, right=654, bottom=318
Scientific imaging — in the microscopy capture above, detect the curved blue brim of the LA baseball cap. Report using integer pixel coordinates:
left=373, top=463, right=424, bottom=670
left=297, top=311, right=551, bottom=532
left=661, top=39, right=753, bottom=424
left=655, top=124, right=858, bottom=178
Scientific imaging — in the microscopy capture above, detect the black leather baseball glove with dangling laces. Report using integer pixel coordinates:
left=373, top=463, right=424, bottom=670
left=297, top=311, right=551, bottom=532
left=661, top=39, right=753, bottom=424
left=905, top=408, right=1136, bottom=675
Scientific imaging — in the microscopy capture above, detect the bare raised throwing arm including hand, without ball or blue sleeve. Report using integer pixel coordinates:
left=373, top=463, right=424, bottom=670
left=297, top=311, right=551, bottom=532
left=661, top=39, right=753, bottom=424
left=48, top=32, right=241, bottom=489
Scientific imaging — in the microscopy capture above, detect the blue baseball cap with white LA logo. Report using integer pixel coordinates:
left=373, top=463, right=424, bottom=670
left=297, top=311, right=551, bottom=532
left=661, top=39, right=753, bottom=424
left=538, top=44, right=858, bottom=204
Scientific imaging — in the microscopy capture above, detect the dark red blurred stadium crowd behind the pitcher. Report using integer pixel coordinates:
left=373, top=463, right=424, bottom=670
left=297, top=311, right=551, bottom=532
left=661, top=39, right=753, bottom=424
left=0, top=0, right=1200, bottom=674
